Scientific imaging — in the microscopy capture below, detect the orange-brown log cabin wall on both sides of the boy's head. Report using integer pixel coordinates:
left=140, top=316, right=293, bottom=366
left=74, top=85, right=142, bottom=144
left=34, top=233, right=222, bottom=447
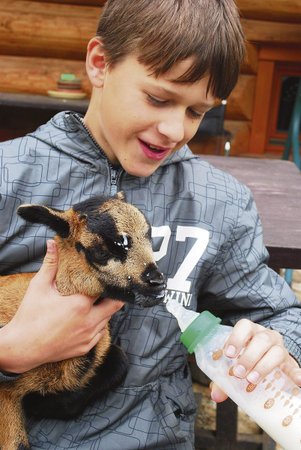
left=0, top=0, right=301, bottom=155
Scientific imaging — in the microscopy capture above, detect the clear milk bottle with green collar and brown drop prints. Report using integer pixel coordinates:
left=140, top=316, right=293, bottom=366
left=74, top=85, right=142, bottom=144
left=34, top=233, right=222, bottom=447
left=166, top=300, right=301, bottom=450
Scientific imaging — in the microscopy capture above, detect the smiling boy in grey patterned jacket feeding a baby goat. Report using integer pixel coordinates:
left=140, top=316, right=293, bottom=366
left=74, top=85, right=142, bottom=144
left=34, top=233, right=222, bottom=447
left=0, top=0, right=301, bottom=450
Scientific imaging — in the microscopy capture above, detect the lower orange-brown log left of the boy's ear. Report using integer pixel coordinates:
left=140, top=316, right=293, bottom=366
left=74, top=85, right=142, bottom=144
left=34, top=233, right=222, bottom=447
left=0, top=56, right=91, bottom=95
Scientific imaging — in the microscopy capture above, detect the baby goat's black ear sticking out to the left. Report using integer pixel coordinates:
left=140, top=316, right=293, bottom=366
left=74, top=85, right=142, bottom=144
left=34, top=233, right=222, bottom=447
left=17, top=205, right=70, bottom=238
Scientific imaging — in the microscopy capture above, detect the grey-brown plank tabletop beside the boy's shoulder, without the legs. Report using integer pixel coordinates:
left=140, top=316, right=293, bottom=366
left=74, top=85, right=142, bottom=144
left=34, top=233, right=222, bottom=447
left=201, top=155, right=301, bottom=270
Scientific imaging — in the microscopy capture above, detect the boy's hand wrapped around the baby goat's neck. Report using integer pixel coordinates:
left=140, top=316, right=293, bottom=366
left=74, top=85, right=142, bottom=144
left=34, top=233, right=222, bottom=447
left=0, top=241, right=123, bottom=373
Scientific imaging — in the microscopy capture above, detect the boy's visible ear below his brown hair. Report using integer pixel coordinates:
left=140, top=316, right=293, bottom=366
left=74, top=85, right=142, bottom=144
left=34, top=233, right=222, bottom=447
left=86, top=37, right=107, bottom=88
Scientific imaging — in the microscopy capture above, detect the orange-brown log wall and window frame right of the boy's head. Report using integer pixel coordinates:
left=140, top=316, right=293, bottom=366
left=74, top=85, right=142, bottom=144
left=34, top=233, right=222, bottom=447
left=211, top=0, right=301, bottom=157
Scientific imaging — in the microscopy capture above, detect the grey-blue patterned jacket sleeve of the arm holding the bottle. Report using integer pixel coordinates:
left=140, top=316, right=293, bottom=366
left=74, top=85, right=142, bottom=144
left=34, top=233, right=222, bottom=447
left=199, top=188, right=301, bottom=365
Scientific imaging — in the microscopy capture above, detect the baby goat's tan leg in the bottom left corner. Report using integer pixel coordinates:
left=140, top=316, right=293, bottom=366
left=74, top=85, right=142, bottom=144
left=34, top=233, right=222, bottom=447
left=0, top=390, right=30, bottom=450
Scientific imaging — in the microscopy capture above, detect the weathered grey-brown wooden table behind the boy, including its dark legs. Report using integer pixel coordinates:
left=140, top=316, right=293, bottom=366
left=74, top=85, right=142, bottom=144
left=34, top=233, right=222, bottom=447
left=191, top=155, right=301, bottom=450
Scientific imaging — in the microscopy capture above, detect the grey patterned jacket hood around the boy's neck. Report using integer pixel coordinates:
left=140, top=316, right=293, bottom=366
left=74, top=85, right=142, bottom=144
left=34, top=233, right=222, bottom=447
left=29, top=111, right=197, bottom=171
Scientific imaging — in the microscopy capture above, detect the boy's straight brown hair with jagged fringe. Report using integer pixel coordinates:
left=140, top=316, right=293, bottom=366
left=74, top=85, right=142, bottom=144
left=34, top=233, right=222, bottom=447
left=97, top=0, right=245, bottom=99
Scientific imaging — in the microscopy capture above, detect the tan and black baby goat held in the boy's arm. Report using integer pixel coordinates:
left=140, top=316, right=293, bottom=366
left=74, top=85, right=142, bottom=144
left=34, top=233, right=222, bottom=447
left=0, top=193, right=165, bottom=450
